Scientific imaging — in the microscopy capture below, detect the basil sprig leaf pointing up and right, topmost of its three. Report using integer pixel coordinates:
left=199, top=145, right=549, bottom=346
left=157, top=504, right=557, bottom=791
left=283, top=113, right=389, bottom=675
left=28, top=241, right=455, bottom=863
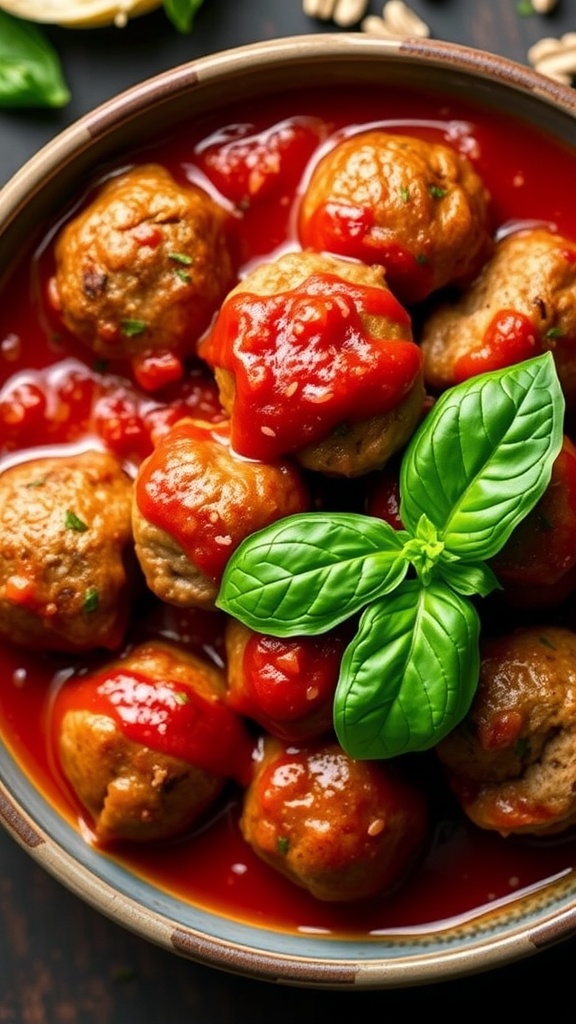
left=400, top=352, right=564, bottom=561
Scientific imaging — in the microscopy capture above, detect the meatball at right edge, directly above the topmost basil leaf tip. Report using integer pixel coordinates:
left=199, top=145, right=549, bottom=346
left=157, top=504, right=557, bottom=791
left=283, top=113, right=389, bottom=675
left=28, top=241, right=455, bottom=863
left=421, top=227, right=576, bottom=404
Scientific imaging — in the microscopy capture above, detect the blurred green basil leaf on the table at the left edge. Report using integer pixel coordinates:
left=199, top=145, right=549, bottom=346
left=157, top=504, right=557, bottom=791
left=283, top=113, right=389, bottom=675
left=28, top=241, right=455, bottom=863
left=0, top=10, right=70, bottom=108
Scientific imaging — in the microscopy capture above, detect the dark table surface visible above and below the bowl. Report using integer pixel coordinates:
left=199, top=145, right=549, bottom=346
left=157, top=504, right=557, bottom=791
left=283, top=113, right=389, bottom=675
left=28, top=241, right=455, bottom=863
left=0, top=0, right=576, bottom=1024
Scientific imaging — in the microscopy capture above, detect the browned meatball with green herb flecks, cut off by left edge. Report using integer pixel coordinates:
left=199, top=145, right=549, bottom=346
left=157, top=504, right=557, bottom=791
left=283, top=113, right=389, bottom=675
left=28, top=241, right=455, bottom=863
left=0, top=452, right=137, bottom=651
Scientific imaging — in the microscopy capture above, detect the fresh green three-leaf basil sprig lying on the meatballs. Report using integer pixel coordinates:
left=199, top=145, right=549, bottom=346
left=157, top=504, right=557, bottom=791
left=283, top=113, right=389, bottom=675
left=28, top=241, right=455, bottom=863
left=217, top=352, right=564, bottom=759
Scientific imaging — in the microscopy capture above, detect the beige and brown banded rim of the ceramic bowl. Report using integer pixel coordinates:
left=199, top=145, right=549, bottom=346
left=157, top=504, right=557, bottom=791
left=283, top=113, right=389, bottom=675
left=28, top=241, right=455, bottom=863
left=0, top=33, right=576, bottom=989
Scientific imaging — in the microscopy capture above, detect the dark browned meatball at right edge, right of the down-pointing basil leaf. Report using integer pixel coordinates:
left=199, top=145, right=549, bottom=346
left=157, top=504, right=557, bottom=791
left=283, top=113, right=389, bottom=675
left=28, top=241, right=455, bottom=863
left=437, top=627, right=576, bottom=836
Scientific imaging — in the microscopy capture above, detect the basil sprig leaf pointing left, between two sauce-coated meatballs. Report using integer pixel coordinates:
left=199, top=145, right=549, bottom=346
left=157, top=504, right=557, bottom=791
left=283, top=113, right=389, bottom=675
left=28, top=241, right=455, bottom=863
left=216, top=512, right=408, bottom=637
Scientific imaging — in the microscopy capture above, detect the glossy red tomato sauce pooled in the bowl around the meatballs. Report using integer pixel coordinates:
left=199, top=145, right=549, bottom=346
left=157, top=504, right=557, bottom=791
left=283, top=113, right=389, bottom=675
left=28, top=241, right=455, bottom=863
left=0, top=90, right=576, bottom=935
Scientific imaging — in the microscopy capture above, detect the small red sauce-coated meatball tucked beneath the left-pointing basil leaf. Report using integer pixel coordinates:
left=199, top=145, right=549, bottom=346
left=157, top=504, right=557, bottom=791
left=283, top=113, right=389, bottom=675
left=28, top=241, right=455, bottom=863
left=225, top=618, right=346, bottom=741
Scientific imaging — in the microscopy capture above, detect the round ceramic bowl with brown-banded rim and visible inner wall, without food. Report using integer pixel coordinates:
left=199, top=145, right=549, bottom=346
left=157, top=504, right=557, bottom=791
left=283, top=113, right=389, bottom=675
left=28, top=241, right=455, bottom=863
left=0, top=34, right=576, bottom=989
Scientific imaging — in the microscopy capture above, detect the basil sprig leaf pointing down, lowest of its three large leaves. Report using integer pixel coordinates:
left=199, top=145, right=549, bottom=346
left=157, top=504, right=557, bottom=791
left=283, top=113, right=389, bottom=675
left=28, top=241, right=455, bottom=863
left=334, top=580, right=480, bottom=759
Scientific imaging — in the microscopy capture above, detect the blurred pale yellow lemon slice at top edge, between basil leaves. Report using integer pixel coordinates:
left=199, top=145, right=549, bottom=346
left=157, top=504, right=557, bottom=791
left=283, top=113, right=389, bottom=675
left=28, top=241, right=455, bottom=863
left=0, top=0, right=162, bottom=29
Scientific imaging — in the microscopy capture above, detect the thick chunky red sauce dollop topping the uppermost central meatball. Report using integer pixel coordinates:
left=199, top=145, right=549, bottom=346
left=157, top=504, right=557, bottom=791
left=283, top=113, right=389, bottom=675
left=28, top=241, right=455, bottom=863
left=201, top=273, right=416, bottom=461
